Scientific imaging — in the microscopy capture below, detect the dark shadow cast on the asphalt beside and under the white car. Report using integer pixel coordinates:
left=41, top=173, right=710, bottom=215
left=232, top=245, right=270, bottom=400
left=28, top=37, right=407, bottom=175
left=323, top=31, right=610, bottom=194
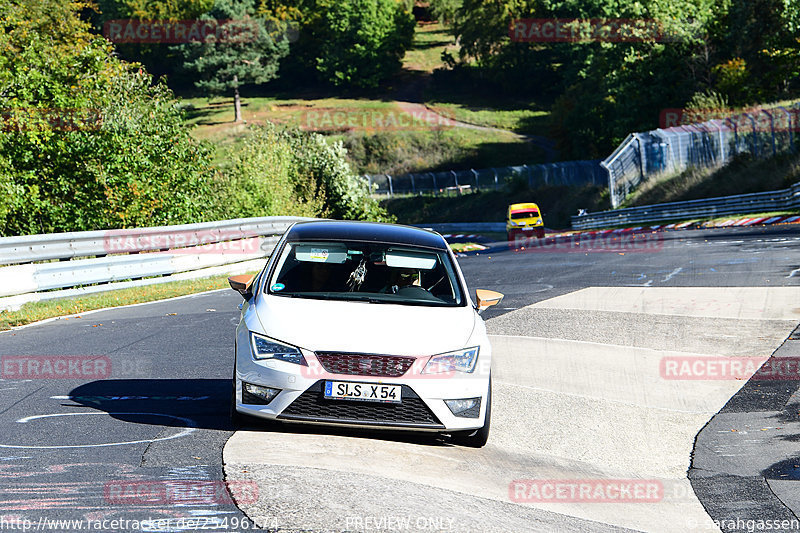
left=62, top=379, right=451, bottom=446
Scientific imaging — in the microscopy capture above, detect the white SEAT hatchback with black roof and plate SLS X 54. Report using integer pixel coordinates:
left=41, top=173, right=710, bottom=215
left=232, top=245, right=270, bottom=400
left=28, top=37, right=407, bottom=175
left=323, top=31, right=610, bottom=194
left=229, top=221, right=503, bottom=446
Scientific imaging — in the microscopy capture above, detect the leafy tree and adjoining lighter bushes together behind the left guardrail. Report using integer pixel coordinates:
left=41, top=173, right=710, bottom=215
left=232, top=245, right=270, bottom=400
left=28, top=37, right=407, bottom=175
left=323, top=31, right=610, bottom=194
left=0, top=0, right=388, bottom=236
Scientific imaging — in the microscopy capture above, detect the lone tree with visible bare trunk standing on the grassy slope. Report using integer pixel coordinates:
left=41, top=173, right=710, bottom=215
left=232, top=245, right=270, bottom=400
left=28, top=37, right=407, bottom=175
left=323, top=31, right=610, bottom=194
left=181, top=0, right=289, bottom=122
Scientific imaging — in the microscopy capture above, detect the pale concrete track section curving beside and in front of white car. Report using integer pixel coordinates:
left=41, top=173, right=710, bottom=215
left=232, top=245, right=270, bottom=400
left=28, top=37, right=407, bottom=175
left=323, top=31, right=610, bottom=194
left=223, top=287, right=800, bottom=532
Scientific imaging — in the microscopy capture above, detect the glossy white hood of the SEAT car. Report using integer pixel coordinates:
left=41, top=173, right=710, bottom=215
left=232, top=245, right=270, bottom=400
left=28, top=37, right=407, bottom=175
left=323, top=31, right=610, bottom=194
left=256, top=295, right=478, bottom=356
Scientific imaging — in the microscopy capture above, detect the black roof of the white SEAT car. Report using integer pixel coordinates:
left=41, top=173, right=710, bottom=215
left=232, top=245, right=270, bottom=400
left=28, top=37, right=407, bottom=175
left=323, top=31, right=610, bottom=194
left=286, top=220, right=447, bottom=250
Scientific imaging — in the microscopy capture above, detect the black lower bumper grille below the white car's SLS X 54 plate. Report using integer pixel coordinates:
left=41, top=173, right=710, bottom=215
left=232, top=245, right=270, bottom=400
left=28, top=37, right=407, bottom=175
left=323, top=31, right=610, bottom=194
left=278, top=380, right=444, bottom=429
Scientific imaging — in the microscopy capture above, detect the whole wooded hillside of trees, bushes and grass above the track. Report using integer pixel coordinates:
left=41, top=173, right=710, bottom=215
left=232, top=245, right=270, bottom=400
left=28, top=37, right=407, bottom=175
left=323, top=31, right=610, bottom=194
left=0, top=0, right=800, bottom=235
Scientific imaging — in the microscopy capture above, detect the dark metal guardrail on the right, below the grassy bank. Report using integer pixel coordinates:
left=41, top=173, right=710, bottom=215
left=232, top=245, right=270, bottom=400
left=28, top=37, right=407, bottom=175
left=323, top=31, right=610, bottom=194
left=572, top=183, right=800, bottom=230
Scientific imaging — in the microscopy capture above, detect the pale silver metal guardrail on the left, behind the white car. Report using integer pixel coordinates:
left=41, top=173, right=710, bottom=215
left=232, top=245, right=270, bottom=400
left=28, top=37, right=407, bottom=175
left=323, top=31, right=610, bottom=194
left=0, top=217, right=310, bottom=310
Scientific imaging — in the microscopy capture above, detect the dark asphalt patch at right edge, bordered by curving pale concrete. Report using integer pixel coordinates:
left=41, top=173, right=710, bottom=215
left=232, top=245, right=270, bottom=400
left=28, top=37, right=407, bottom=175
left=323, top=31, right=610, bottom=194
left=689, top=327, right=800, bottom=531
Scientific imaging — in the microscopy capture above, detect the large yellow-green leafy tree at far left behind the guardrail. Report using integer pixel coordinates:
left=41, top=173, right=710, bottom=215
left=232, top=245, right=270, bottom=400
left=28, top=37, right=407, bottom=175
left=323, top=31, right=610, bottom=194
left=0, top=0, right=214, bottom=235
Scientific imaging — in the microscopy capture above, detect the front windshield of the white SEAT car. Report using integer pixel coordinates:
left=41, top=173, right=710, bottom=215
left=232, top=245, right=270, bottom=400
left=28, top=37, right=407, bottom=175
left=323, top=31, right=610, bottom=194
left=267, top=242, right=465, bottom=306
